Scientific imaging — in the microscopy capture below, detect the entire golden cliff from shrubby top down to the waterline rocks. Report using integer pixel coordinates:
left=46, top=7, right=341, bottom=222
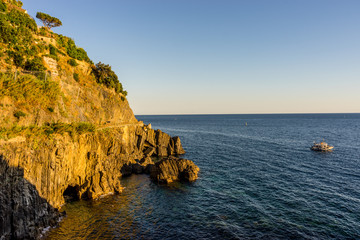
left=0, top=0, right=198, bottom=240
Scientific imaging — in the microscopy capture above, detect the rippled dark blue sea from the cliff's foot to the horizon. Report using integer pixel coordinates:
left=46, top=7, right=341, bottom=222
left=47, top=114, right=360, bottom=239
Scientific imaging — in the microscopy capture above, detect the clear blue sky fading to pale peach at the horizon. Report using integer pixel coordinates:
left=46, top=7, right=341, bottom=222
left=23, top=0, right=360, bottom=114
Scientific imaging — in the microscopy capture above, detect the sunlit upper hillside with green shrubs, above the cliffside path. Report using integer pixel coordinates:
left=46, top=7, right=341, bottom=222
left=0, top=0, right=137, bottom=131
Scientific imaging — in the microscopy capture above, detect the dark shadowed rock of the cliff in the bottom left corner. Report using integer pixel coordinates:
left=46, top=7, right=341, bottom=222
left=0, top=155, right=62, bottom=239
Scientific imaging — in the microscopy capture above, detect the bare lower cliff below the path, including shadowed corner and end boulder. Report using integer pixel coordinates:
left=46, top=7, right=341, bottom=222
left=0, top=125, right=199, bottom=239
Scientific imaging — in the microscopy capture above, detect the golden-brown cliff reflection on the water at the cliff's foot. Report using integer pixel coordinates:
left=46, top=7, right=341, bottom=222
left=46, top=175, right=152, bottom=240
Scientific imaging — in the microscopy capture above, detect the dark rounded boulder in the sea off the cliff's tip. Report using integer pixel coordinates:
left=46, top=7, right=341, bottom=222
left=150, top=157, right=200, bottom=183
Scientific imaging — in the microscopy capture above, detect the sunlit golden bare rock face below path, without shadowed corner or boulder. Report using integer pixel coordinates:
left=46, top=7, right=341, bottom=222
left=0, top=125, right=184, bottom=208
